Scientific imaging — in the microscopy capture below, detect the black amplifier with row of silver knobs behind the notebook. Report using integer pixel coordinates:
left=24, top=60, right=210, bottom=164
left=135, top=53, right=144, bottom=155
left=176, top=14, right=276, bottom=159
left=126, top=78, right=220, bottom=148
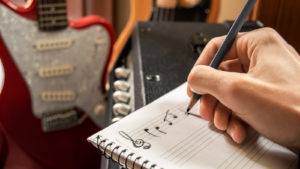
left=106, top=22, right=263, bottom=169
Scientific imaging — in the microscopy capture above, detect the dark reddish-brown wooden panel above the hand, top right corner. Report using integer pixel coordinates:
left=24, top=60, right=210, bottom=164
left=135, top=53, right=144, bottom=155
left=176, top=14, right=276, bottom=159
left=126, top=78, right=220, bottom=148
left=257, top=0, right=300, bottom=52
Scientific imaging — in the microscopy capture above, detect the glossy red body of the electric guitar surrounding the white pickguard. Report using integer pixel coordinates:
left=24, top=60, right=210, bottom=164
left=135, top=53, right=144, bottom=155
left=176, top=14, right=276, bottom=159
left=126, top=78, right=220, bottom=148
left=0, top=0, right=114, bottom=169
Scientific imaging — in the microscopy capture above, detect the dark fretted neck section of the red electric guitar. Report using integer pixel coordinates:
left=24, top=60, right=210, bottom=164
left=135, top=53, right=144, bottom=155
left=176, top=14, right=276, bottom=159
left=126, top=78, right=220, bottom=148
left=36, top=0, right=68, bottom=31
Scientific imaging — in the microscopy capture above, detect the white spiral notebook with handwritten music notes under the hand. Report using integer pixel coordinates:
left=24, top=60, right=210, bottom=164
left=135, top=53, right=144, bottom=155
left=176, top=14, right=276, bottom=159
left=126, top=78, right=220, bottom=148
left=88, top=83, right=297, bottom=169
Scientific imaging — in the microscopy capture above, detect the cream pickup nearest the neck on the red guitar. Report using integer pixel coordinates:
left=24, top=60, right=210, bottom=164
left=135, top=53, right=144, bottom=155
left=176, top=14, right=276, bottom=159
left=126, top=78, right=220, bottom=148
left=33, top=38, right=73, bottom=51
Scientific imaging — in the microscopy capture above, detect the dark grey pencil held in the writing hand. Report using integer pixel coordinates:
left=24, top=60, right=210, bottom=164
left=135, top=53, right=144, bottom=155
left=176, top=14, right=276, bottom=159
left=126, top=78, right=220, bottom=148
left=186, top=0, right=256, bottom=113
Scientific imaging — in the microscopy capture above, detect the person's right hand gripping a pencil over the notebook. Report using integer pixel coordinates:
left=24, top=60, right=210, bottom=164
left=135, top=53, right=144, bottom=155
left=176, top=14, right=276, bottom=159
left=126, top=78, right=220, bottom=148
left=188, top=28, right=300, bottom=152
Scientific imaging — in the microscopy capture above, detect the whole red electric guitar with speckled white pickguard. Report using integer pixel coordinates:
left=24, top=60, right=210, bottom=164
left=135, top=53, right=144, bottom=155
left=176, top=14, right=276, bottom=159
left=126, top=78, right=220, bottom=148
left=0, top=0, right=114, bottom=169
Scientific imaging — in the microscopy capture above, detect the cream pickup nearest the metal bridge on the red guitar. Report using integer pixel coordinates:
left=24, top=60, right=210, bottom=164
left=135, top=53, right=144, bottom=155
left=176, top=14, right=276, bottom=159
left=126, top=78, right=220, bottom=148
left=41, top=90, right=76, bottom=102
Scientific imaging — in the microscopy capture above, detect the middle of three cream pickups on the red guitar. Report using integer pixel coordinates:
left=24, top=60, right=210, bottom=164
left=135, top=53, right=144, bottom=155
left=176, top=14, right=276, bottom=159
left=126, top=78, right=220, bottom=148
left=38, top=64, right=75, bottom=78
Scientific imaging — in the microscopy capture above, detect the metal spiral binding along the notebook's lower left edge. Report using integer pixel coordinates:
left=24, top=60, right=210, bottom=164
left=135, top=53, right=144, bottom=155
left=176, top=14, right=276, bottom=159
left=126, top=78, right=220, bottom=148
left=96, top=135, right=161, bottom=169
